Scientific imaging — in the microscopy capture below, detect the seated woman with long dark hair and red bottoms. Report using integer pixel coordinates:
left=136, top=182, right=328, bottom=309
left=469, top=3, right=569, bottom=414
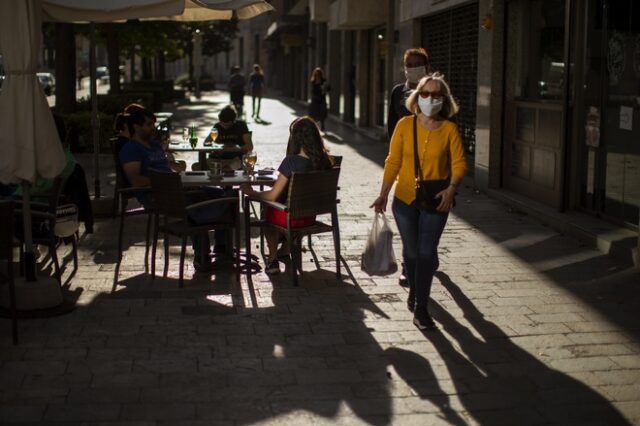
left=241, top=116, right=333, bottom=274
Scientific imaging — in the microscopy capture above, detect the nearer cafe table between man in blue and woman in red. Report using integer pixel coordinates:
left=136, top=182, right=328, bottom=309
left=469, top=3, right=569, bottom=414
left=180, top=171, right=276, bottom=274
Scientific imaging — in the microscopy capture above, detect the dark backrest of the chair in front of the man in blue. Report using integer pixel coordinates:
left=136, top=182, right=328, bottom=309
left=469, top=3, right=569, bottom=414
left=149, top=169, right=187, bottom=218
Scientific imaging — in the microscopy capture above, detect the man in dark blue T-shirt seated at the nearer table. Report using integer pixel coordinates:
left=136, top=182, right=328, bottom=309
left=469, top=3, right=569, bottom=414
left=118, top=108, right=228, bottom=272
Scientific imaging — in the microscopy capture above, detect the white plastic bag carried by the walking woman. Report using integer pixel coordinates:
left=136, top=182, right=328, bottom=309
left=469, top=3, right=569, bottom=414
left=360, top=213, right=398, bottom=275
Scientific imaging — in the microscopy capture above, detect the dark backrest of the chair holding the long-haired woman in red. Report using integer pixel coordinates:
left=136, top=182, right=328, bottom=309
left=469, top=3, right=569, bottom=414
left=287, top=168, right=340, bottom=218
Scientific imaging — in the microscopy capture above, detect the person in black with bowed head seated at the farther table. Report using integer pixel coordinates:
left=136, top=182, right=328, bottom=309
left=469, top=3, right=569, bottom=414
left=205, top=105, right=253, bottom=160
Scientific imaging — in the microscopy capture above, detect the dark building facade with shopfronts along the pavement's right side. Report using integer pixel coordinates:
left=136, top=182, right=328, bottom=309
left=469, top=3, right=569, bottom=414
left=211, top=0, right=640, bottom=262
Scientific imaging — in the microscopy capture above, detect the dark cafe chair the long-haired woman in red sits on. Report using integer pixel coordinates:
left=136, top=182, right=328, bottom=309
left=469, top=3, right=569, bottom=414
left=245, top=167, right=341, bottom=286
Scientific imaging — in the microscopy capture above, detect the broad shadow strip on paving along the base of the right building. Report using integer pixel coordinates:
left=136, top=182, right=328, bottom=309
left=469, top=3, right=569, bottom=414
left=452, top=194, right=640, bottom=339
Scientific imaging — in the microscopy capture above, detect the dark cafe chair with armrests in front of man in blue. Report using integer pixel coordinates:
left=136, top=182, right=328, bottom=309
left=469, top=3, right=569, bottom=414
left=149, top=170, right=240, bottom=287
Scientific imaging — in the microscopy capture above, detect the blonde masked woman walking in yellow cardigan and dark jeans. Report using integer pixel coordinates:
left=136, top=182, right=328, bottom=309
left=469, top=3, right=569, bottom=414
left=371, top=73, right=467, bottom=330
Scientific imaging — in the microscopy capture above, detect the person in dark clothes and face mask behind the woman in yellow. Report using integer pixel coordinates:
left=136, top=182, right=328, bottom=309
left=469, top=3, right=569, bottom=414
left=387, top=47, right=438, bottom=287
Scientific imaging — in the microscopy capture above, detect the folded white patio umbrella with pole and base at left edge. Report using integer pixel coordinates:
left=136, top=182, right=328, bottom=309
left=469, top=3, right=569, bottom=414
left=0, top=0, right=64, bottom=308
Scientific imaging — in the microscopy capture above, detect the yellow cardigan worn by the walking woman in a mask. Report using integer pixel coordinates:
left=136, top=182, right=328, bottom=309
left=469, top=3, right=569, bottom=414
left=382, top=115, right=467, bottom=204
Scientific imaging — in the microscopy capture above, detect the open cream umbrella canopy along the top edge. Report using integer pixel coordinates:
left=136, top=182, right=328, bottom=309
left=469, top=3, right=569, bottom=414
left=42, top=0, right=273, bottom=22
